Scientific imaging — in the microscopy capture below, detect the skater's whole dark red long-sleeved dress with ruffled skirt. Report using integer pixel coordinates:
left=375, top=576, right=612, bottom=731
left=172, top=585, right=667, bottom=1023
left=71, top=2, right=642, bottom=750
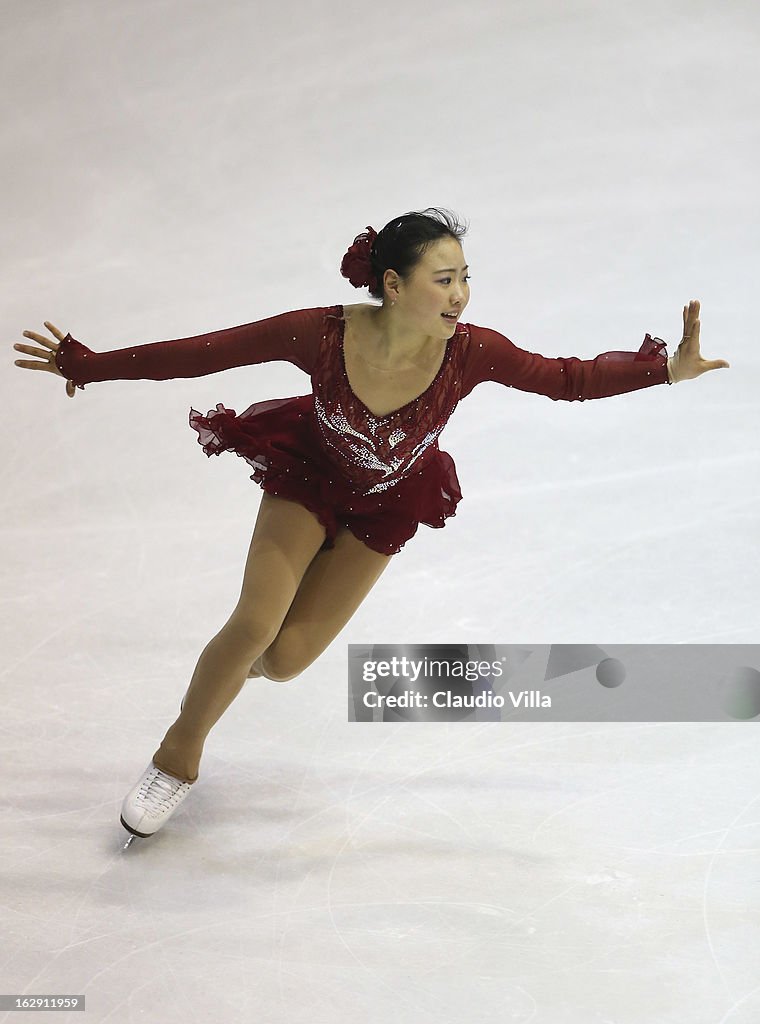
left=55, top=305, right=670, bottom=555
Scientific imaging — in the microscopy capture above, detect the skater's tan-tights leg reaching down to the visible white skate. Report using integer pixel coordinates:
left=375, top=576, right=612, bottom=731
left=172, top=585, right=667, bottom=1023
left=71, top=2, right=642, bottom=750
left=153, top=493, right=325, bottom=782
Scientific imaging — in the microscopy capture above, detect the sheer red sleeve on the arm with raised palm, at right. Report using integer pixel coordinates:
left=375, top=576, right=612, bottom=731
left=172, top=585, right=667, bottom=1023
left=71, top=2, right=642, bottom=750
left=462, top=324, right=670, bottom=401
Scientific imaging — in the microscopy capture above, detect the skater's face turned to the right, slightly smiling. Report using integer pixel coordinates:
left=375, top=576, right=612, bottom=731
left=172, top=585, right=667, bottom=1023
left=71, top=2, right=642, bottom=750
left=396, top=238, right=470, bottom=338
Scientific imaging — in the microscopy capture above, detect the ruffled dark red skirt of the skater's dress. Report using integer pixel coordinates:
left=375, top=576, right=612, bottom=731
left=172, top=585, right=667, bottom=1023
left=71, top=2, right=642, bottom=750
left=189, top=394, right=462, bottom=555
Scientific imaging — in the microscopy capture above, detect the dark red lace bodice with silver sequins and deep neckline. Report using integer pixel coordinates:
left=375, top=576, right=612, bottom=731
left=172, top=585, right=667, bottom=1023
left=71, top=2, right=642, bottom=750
left=312, top=305, right=466, bottom=495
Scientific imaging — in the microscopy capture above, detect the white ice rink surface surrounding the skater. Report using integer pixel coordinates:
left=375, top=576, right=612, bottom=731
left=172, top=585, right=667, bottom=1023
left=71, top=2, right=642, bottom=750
left=0, top=0, right=760, bottom=1024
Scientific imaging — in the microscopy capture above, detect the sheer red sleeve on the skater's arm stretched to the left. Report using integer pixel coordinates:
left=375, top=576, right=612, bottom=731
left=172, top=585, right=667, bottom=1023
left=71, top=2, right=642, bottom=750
left=55, top=307, right=325, bottom=390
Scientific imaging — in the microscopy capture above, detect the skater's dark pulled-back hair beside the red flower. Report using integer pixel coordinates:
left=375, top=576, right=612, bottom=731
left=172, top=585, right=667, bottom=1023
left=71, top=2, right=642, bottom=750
left=370, top=207, right=469, bottom=299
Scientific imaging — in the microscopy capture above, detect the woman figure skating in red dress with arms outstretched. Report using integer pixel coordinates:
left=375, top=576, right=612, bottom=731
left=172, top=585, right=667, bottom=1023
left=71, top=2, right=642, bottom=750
left=13, top=208, right=728, bottom=845
